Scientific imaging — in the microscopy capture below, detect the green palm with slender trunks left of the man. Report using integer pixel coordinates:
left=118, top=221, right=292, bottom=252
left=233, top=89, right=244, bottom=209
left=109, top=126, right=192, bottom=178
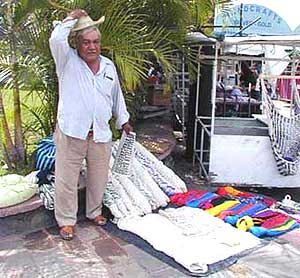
left=0, top=1, right=57, bottom=166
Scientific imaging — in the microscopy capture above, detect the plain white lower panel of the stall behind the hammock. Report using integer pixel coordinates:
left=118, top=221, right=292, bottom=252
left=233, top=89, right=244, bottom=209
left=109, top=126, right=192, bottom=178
left=209, top=135, right=300, bottom=187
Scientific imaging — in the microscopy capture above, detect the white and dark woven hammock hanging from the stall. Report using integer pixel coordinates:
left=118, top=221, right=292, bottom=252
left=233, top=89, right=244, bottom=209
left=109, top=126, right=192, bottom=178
left=260, top=78, right=300, bottom=176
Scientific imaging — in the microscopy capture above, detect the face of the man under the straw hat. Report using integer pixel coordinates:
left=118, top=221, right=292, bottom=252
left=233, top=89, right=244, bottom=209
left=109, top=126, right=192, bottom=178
left=77, top=30, right=101, bottom=63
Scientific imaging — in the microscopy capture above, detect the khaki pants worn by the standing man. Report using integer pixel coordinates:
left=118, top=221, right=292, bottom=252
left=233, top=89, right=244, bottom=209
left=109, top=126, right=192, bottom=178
left=54, top=127, right=111, bottom=227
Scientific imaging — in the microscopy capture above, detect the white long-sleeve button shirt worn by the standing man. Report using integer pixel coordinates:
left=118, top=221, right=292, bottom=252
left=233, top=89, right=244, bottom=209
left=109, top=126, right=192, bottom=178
left=49, top=20, right=129, bottom=142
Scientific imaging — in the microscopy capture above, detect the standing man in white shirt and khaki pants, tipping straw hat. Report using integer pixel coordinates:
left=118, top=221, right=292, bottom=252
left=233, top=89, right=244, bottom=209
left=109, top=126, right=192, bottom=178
left=49, top=10, right=132, bottom=240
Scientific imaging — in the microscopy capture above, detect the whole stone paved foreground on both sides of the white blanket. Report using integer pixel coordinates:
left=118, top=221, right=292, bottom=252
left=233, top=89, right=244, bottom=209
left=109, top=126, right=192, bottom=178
left=0, top=212, right=300, bottom=278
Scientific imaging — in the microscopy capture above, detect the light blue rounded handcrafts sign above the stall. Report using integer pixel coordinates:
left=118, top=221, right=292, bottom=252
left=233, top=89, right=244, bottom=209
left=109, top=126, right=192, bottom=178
left=215, top=4, right=292, bottom=36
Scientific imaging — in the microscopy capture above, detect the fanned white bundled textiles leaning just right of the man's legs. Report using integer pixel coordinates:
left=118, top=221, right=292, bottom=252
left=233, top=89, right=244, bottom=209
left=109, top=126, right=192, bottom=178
left=103, top=141, right=187, bottom=222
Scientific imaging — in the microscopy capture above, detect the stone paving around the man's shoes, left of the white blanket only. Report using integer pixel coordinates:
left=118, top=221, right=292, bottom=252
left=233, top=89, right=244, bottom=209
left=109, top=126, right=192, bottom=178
left=0, top=220, right=195, bottom=278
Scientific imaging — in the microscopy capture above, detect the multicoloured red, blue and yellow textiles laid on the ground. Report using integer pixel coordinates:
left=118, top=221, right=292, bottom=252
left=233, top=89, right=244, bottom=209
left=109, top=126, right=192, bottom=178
left=170, top=186, right=299, bottom=237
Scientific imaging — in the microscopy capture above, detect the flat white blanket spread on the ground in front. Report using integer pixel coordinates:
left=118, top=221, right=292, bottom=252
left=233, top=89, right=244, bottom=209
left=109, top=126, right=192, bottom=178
left=118, top=207, right=261, bottom=274
